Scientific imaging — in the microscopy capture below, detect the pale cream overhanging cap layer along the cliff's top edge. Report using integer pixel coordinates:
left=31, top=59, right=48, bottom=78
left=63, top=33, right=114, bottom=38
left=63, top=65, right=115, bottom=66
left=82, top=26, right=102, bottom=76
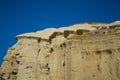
left=16, top=21, right=120, bottom=39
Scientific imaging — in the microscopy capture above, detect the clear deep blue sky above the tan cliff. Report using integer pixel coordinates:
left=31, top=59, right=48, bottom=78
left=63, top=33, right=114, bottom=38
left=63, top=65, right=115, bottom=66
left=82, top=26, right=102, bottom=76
left=0, top=0, right=120, bottom=64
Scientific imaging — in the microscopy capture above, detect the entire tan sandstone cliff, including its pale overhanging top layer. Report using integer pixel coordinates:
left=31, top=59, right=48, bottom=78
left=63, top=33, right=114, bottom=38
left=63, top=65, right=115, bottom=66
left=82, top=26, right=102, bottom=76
left=0, top=21, right=120, bottom=80
